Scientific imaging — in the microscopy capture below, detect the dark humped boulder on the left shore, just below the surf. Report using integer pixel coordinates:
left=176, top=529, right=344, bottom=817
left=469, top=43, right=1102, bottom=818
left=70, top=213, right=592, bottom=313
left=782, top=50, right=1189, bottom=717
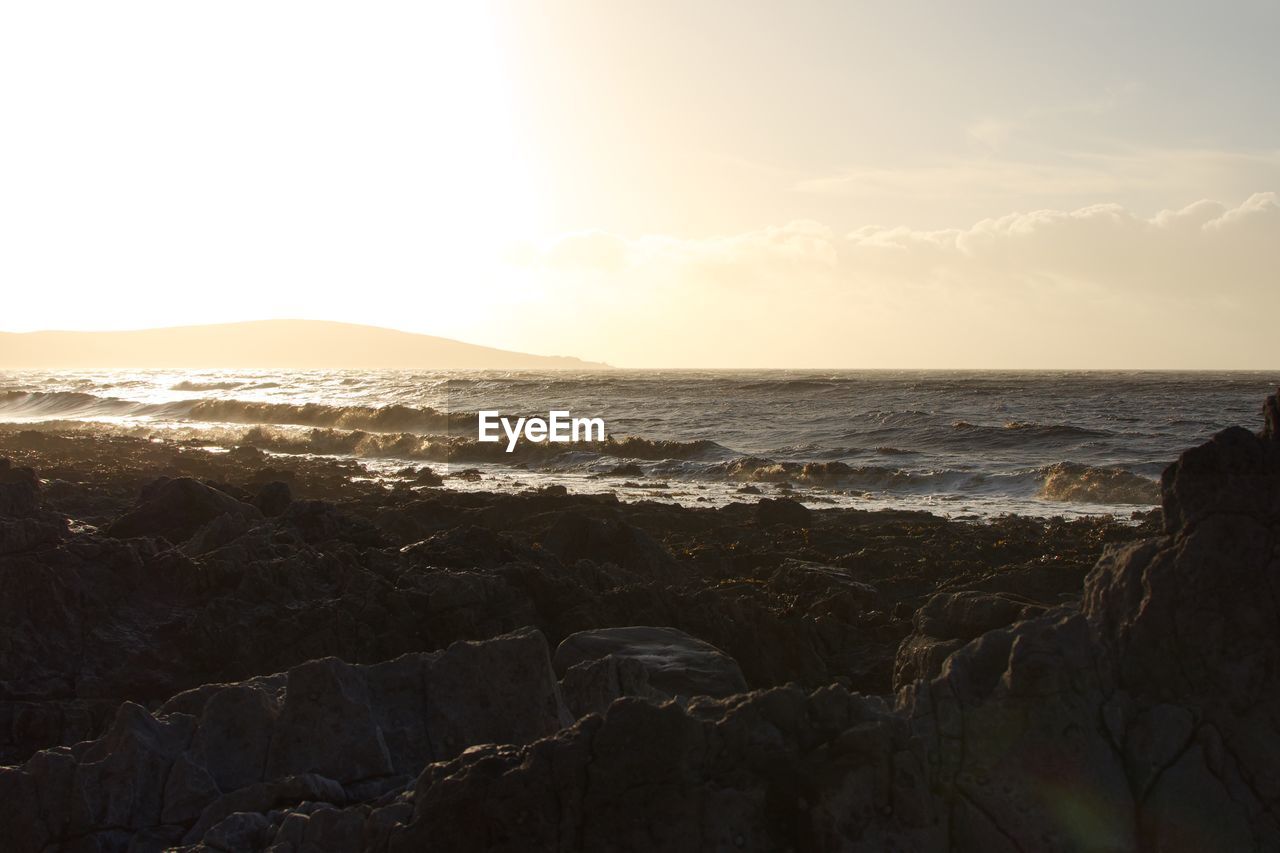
left=105, top=476, right=261, bottom=543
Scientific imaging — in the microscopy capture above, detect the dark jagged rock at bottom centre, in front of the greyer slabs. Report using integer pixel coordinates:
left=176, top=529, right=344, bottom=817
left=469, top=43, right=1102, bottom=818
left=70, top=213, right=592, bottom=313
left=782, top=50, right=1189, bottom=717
left=387, top=688, right=946, bottom=852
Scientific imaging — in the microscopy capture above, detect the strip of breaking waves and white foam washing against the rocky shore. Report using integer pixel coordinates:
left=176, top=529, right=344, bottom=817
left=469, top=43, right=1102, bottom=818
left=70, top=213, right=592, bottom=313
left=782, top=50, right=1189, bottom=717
left=0, top=407, right=1158, bottom=520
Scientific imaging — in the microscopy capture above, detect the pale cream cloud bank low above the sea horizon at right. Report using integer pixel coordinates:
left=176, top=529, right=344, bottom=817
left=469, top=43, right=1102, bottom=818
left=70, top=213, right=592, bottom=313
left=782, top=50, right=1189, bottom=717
left=504, top=192, right=1280, bottom=368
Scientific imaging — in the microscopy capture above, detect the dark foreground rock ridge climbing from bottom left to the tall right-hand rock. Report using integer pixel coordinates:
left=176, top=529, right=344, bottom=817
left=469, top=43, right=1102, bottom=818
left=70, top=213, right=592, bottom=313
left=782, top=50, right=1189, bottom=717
left=94, top=391, right=1280, bottom=852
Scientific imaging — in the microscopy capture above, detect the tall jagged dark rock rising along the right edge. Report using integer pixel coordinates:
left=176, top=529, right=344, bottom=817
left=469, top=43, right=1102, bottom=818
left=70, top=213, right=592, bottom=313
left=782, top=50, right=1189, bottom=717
left=904, top=389, right=1280, bottom=850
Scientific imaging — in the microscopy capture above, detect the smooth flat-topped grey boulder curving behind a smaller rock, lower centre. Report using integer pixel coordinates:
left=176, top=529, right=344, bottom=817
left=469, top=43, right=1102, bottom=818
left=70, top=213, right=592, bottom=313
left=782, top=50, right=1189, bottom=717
left=554, top=625, right=748, bottom=697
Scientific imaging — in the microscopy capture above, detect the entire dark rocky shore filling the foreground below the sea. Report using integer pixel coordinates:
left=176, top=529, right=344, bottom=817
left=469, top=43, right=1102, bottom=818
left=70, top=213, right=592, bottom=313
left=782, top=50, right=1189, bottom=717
left=0, top=398, right=1280, bottom=852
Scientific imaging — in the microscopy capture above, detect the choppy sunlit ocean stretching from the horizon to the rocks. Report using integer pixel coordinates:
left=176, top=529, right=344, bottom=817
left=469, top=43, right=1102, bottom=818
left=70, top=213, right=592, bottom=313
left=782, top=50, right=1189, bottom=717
left=0, top=370, right=1280, bottom=517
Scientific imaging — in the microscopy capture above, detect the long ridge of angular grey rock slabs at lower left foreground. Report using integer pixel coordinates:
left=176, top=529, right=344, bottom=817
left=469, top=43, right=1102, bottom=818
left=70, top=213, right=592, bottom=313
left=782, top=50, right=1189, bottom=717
left=0, top=630, right=572, bottom=853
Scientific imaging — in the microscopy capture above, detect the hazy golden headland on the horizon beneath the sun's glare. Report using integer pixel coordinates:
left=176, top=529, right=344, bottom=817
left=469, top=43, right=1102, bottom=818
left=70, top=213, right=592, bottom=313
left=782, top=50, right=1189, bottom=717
left=0, top=320, right=608, bottom=370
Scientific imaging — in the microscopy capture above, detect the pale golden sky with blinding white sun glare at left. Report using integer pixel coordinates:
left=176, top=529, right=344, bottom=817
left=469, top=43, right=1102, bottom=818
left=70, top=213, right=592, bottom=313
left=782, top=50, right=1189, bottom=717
left=0, top=0, right=1280, bottom=369
